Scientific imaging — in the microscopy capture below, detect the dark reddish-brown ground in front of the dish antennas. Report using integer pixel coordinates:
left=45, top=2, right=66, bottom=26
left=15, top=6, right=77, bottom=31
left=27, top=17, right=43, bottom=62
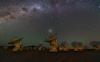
left=0, top=51, right=100, bottom=62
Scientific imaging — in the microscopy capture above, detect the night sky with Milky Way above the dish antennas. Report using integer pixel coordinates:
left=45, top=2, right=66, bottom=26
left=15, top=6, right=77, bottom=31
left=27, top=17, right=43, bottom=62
left=0, top=0, right=100, bottom=45
